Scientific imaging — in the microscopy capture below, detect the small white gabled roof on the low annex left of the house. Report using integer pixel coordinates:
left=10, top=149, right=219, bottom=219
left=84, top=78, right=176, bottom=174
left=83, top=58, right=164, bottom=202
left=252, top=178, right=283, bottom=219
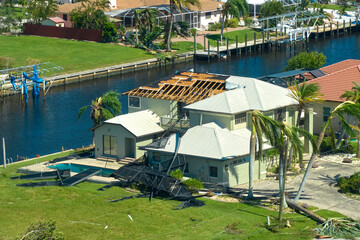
left=105, top=110, right=164, bottom=137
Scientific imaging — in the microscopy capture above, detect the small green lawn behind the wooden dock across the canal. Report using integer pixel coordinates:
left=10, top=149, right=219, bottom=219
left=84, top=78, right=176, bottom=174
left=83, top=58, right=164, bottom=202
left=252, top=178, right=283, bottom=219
left=207, top=29, right=266, bottom=46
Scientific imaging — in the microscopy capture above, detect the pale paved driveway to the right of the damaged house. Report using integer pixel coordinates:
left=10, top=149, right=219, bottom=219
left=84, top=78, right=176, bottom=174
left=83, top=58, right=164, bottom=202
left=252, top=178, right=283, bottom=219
left=236, top=157, right=360, bottom=220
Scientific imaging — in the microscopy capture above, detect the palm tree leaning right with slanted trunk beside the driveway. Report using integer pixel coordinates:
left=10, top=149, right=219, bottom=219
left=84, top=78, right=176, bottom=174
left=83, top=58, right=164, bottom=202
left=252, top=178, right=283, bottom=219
left=294, top=101, right=360, bottom=202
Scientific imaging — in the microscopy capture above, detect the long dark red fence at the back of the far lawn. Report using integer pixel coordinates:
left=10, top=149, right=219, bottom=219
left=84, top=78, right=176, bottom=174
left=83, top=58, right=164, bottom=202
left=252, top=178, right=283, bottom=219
left=24, top=23, right=102, bottom=42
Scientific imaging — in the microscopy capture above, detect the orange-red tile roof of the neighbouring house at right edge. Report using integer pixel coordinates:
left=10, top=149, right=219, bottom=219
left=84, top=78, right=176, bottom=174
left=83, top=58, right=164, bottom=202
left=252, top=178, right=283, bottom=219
left=308, top=64, right=360, bottom=102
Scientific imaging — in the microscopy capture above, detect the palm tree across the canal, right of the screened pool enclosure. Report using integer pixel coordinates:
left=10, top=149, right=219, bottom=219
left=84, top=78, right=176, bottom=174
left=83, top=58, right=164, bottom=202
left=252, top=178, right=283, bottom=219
left=220, top=0, right=249, bottom=42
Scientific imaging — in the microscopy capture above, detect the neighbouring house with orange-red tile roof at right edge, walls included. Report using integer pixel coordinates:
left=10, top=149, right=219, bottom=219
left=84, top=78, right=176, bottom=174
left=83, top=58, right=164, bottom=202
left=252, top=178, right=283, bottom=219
left=308, top=59, right=360, bottom=134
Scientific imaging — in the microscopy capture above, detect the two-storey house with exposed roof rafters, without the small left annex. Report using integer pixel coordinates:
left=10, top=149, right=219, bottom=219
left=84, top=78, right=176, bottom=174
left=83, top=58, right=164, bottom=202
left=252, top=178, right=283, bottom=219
left=119, top=72, right=312, bottom=186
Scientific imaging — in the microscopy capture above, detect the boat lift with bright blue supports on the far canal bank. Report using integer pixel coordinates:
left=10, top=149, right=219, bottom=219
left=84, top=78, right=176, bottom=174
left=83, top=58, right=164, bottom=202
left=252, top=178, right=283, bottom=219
left=0, top=62, right=63, bottom=102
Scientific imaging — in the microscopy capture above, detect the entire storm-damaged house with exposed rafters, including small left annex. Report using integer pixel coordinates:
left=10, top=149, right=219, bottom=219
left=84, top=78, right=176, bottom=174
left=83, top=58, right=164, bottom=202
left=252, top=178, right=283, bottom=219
left=91, top=72, right=311, bottom=186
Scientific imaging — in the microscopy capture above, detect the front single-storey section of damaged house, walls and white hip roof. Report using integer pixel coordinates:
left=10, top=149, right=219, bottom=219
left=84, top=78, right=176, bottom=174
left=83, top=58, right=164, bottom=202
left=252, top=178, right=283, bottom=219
left=141, top=123, right=271, bottom=187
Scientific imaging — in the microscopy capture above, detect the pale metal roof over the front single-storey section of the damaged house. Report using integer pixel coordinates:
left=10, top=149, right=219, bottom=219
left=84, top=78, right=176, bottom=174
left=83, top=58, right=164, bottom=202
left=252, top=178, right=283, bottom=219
left=143, top=123, right=271, bottom=160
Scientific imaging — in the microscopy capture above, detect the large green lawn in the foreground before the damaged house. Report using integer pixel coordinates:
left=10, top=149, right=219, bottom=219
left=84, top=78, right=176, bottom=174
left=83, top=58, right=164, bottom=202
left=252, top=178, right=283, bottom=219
left=0, top=152, right=346, bottom=240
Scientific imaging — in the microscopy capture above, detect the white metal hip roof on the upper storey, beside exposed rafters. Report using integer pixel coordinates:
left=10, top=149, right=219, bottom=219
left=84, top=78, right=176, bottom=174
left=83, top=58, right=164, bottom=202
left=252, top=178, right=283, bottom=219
left=185, top=76, right=297, bottom=114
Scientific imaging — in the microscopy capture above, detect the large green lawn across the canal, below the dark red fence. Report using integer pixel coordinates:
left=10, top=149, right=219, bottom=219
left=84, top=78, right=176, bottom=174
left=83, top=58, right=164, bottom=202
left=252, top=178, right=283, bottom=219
left=0, top=36, right=154, bottom=73
